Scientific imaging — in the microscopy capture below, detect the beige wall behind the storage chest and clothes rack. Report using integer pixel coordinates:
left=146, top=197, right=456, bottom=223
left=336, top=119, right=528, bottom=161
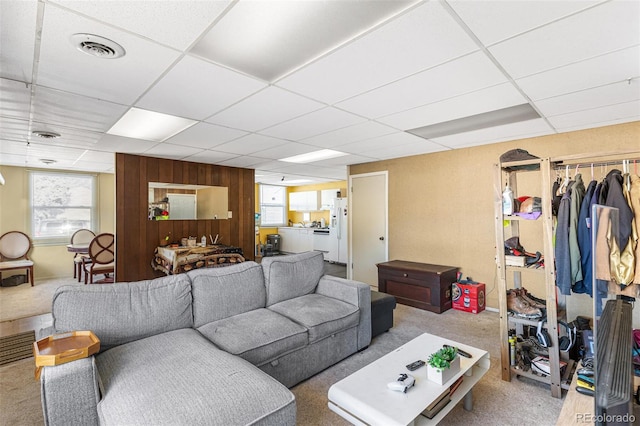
left=349, top=122, right=640, bottom=308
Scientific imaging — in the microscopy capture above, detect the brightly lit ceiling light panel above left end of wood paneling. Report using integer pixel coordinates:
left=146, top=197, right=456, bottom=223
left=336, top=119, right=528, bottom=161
left=107, top=108, right=197, bottom=142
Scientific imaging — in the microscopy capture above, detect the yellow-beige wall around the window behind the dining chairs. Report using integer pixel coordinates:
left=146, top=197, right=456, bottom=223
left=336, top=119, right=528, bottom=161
left=0, top=166, right=115, bottom=281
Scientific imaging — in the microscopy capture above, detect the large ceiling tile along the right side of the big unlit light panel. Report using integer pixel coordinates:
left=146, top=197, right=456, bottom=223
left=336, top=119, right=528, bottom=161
left=277, top=2, right=477, bottom=104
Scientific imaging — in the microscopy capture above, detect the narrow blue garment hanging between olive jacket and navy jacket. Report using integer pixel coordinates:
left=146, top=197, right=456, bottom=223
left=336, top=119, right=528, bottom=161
left=573, top=180, right=598, bottom=296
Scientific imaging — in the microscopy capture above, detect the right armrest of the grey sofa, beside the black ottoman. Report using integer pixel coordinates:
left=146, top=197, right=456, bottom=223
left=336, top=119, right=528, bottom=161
left=316, top=275, right=371, bottom=350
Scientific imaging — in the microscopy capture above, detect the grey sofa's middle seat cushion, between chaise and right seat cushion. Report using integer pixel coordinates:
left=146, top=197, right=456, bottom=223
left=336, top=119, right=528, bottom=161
left=198, top=309, right=308, bottom=365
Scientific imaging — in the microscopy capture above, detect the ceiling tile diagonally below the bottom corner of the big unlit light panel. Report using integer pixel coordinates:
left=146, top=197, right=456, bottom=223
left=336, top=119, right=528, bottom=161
left=207, top=86, right=325, bottom=132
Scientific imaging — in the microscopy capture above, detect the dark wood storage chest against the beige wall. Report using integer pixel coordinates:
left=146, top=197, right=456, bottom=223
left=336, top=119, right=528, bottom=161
left=377, top=260, right=458, bottom=314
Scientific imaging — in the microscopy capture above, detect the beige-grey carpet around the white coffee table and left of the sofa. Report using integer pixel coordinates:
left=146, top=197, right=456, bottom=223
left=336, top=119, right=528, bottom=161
left=0, top=305, right=563, bottom=426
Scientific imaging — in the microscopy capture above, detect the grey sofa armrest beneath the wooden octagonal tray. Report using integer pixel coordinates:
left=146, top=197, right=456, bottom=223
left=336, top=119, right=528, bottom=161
left=40, top=356, right=100, bottom=426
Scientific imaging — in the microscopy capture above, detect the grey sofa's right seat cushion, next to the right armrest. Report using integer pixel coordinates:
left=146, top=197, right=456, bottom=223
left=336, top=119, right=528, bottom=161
left=269, top=294, right=360, bottom=343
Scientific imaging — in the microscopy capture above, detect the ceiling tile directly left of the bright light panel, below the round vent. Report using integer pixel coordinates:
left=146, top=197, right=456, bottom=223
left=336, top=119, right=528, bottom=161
left=33, top=86, right=127, bottom=132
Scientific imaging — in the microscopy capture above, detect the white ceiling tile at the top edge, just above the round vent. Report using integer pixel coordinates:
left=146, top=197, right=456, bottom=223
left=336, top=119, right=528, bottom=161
left=53, top=0, right=231, bottom=50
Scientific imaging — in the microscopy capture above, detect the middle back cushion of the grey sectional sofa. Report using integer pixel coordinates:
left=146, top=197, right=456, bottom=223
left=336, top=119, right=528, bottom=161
left=187, top=262, right=266, bottom=327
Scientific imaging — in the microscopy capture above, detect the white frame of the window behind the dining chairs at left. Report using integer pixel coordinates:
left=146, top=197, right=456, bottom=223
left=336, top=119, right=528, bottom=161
left=28, top=170, right=100, bottom=245
